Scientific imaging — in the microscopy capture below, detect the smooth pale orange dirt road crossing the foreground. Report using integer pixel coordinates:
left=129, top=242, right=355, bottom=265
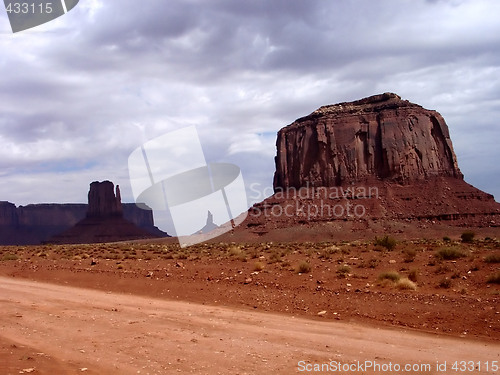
left=0, top=277, right=500, bottom=375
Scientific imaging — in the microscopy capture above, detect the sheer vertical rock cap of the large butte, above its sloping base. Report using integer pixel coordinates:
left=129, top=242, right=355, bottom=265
left=274, top=93, right=463, bottom=190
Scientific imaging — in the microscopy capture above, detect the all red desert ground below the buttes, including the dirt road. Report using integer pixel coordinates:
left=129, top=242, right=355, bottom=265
left=0, top=236, right=500, bottom=374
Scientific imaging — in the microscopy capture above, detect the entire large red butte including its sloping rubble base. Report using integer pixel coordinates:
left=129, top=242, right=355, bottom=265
left=232, top=93, right=500, bottom=240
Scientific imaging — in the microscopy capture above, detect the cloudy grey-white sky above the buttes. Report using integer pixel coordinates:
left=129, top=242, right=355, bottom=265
left=0, top=0, right=500, bottom=232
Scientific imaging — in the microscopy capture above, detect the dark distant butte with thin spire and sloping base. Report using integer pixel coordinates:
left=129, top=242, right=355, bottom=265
left=47, top=181, right=166, bottom=244
